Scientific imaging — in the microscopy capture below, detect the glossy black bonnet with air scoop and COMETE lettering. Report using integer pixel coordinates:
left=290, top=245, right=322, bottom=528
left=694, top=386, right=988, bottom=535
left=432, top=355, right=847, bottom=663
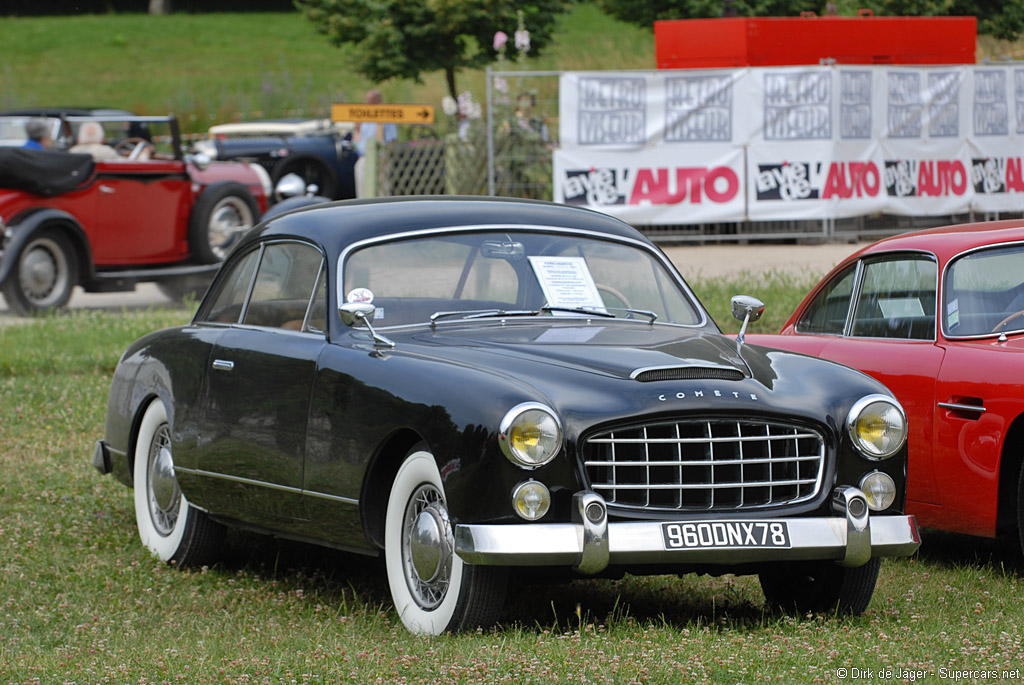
left=387, top=320, right=890, bottom=418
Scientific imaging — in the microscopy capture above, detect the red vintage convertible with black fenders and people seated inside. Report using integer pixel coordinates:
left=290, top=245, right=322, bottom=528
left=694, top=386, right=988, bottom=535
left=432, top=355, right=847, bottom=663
left=0, top=115, right=270, bottom=314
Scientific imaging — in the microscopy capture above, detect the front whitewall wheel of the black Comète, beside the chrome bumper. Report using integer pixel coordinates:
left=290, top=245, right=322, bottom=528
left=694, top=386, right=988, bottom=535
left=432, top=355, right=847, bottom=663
left=384, top=445, right=508, bottom=635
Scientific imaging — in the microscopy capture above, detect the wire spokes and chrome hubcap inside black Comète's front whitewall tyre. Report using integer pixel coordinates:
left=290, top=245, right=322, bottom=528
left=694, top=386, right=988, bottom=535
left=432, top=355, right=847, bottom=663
left=401, top=485, right=455, bottom=609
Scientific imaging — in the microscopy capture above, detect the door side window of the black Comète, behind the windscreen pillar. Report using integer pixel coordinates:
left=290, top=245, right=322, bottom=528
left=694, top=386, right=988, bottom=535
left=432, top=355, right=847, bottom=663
left=242, top=243, right=324, bottom=331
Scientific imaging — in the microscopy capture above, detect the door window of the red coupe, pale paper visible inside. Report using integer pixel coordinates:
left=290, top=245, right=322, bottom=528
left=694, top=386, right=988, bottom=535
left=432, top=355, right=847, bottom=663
left=853, top=256, right=938, bottom=340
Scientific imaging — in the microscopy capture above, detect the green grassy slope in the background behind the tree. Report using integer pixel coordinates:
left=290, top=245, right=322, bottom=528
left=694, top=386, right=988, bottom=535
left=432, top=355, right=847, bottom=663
left=0, top=4, right=654, bottom=132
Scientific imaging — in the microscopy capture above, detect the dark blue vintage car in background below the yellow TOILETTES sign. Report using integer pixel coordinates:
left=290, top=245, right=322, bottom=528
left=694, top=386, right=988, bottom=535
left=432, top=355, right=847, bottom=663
left=195, top=119, right=359, bottom=200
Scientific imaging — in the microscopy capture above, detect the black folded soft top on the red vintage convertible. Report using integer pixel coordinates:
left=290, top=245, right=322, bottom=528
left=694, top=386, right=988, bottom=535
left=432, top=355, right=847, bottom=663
left=0, top=147, right=95, bottom=196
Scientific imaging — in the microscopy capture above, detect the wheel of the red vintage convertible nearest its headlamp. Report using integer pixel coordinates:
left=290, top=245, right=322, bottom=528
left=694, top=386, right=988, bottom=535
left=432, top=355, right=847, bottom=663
left=188, top=181, right=259, bottom=264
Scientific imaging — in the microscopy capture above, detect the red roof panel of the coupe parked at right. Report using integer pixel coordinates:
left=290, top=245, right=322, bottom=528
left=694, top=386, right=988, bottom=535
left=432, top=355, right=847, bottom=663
left=846, top=219, right=1024, bottom=263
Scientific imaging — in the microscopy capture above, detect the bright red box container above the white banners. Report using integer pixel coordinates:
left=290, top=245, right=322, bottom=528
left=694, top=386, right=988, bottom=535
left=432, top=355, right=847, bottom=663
left=654, top=12, right=978, bottom=69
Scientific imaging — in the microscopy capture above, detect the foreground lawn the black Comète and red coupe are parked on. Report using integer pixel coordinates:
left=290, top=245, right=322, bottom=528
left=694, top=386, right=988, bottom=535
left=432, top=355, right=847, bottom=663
left=0, top=277, right=1024, bottom=683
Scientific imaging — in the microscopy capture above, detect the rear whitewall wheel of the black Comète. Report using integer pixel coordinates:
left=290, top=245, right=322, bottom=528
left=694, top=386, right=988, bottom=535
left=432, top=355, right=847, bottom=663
left=132, top=399, right=224, bottom=566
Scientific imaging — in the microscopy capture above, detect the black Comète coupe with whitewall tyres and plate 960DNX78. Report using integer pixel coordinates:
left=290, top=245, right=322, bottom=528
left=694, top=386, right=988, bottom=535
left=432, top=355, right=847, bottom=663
left=93, top=198, right=919, bottom=633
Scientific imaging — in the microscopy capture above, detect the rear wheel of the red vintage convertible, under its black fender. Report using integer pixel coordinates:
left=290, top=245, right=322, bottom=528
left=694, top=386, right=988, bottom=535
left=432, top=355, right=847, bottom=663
left=3, top=228, right=78, bottom=316
